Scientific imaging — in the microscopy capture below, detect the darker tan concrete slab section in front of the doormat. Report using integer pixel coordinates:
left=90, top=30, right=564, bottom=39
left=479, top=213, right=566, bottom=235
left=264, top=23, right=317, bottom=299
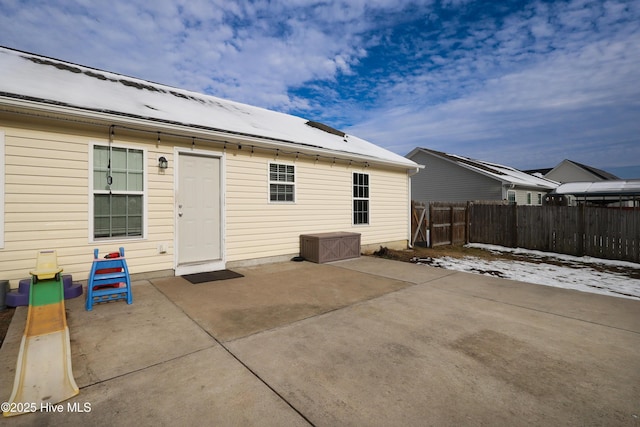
left=152, top=262, right=410, bottom=341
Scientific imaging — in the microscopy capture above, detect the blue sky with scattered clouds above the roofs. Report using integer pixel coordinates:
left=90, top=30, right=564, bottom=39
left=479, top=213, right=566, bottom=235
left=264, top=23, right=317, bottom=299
left=0, top=0, right=640, bottom=178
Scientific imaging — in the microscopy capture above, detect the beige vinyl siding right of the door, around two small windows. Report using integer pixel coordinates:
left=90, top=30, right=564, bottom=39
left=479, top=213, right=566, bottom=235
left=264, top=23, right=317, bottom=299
left=226, top=153, right=408, bottom=262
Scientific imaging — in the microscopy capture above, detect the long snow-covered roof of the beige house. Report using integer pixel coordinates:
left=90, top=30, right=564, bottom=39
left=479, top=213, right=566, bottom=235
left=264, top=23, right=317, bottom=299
left=0, top=47, right=418, bottom=168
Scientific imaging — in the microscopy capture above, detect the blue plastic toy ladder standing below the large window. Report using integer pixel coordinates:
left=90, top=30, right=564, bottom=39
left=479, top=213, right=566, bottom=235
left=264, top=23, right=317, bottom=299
left=86, top=248, right=133, bottom=311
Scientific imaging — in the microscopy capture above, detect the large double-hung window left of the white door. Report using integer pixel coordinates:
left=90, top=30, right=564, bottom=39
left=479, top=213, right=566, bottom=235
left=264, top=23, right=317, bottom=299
left=93, top=145, right=145, bottom=239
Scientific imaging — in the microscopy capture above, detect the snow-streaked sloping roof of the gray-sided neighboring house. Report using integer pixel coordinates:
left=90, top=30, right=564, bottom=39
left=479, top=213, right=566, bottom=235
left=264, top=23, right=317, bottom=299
left=412, top=148, right=558, bottom=190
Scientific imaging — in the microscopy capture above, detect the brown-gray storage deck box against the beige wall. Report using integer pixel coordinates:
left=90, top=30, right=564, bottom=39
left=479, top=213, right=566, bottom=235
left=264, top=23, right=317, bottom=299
left=300, top=231, right=360, bottom=264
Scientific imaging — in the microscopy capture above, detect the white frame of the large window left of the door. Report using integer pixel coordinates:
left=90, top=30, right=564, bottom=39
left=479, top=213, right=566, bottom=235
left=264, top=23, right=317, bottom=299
left=87, top=142, right=149, bottom=243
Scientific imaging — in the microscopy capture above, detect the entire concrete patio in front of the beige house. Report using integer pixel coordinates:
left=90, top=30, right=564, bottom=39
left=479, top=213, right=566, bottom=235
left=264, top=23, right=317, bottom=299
left=0, top=257, right=640, bottom=426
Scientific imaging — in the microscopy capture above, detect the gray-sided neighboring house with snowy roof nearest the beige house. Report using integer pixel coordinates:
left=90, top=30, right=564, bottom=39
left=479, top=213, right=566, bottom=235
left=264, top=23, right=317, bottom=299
left=406, top=148, right=558, bottom=205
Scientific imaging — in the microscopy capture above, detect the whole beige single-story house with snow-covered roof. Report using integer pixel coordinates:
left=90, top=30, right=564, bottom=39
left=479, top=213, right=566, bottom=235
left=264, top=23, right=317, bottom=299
left=0, top=48, right=418, bottom=284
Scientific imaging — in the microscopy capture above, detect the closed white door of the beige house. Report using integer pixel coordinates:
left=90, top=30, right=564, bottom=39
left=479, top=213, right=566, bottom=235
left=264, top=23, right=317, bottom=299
left=175, top=153, right=224, bottom=275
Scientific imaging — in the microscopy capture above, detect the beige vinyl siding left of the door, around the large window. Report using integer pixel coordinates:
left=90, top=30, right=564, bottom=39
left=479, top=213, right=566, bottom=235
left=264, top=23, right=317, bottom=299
left=0, top=120, right=173, bottom=287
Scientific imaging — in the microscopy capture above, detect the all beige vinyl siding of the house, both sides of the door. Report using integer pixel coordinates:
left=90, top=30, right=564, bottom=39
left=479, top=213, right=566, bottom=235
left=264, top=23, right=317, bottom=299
left=0, top=116, right=409, bottom=287
